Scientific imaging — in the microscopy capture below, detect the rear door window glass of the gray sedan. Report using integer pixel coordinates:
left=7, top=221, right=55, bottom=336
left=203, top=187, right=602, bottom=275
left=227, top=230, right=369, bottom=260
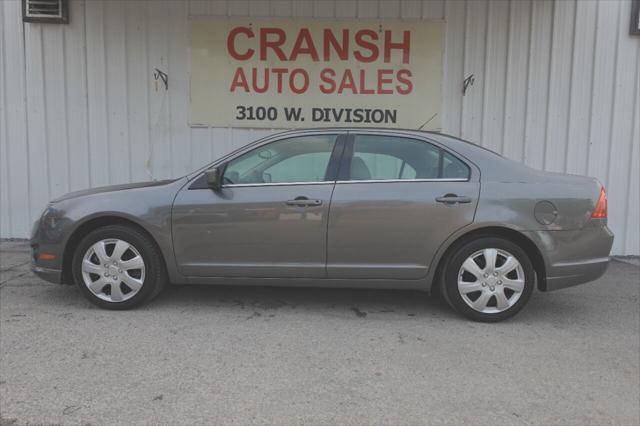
left=350, top=135, right=470, bottom=180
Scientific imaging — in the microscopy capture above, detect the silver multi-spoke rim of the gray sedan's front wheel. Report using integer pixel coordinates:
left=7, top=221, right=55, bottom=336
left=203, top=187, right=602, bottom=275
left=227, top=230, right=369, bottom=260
left=82, top=239, right=145, bottom=302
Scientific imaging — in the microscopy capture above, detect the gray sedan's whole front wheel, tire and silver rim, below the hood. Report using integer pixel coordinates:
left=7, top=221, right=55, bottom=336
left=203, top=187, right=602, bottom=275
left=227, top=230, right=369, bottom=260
left=72, top=225, right=166, bottom=309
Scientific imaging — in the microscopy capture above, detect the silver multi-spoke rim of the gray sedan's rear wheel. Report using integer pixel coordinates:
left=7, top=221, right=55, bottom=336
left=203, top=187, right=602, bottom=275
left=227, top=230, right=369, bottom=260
left=458, top=248, right=524, bottom=314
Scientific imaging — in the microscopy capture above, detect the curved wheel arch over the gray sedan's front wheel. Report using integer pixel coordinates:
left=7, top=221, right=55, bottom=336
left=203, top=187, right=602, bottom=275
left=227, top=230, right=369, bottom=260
left=62, top=214, right=167, bottom=283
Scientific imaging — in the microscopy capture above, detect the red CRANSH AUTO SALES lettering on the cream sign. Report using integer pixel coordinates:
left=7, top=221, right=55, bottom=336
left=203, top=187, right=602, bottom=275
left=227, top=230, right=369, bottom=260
left=227, top=26, right=413, bottom=95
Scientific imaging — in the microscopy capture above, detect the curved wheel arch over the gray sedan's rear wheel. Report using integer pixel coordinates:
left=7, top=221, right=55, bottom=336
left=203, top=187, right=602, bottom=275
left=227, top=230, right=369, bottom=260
left=431, top=226, right=547, bottom=291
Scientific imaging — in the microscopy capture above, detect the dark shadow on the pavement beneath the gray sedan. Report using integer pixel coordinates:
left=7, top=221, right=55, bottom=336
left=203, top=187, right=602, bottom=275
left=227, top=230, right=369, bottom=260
left=15, top=277, right=594, bottom=325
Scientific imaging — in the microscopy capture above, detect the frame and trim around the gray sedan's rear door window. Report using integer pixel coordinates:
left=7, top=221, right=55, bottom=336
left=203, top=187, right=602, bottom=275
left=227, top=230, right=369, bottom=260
left=336, top=132, right=473, bottom=183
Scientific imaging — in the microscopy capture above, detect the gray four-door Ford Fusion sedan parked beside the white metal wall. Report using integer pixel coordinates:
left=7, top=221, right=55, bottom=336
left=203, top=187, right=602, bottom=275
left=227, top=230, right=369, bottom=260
left=31, top=129, right=613, bottom=321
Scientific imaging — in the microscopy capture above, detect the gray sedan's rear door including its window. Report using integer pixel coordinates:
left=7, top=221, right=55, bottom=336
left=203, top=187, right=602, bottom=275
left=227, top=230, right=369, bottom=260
left=327, top=132, right=480, bottom=279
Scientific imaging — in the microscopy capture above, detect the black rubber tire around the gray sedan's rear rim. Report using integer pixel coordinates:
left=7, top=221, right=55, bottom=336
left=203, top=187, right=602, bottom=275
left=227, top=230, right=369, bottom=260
left=442, top=237, right=535, bottom=322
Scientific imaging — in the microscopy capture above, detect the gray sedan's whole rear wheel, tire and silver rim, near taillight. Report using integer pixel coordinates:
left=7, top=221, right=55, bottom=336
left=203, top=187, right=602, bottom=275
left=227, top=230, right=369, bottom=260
left=444, top=237, right=535, bottom=322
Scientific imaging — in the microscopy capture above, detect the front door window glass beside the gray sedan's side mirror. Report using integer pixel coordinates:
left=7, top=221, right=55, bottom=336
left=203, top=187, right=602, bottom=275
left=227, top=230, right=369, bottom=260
left=224, top=135, right=337, bottom=184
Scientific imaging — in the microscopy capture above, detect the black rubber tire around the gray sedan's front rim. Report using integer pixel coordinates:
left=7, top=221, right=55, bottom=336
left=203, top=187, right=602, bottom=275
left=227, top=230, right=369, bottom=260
left=71, top=225, right=167, bottom=310
